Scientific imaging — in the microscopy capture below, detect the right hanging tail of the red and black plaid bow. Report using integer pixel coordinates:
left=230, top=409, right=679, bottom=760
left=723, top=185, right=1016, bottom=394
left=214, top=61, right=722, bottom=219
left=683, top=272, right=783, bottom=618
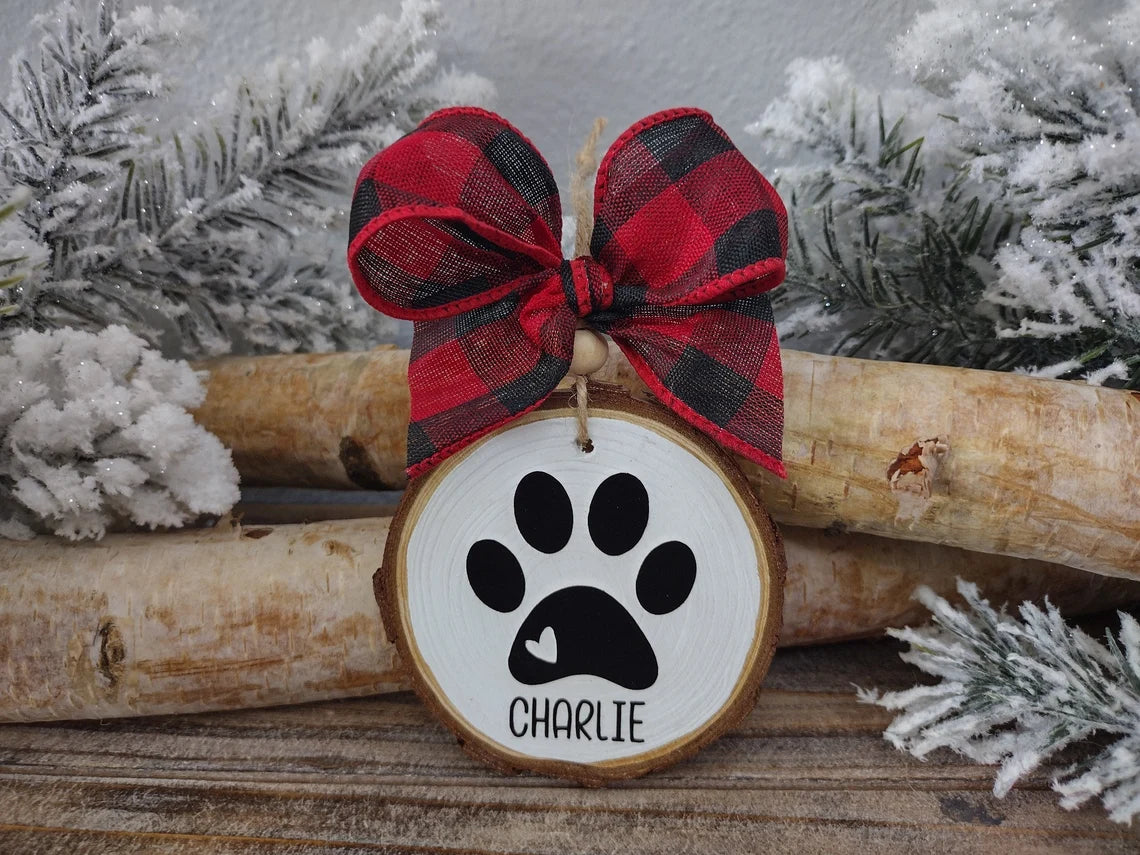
left=605, top=294, right=788, bottom=478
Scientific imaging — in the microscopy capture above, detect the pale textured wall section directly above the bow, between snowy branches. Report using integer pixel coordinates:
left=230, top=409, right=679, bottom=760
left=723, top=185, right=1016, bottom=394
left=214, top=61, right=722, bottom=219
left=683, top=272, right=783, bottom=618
left=435, top=0, right=915, bottom=174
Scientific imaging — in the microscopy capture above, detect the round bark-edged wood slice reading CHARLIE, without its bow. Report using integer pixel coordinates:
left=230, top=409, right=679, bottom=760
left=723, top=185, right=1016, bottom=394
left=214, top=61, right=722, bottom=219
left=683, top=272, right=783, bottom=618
left=375, top=389, right=784, bottom=784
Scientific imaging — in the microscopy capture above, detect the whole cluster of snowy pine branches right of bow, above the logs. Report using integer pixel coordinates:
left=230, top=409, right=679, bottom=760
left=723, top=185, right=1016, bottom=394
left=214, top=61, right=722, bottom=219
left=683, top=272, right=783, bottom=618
left=751, top=0, right=1140, bottom=388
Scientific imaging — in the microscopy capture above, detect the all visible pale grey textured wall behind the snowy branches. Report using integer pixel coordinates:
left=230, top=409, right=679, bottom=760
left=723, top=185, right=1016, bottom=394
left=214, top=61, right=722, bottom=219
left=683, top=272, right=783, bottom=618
left=0, top=0, right=919, bottom=185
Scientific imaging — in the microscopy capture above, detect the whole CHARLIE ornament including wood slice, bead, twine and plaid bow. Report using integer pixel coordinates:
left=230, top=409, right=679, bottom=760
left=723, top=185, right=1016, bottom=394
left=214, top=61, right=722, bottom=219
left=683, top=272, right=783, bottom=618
left=349, top=107, right=787, bottom=783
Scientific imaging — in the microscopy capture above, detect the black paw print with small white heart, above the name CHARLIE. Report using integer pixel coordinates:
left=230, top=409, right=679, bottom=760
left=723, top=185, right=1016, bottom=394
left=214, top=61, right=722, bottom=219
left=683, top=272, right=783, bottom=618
left=467, top=472, right=697, bottom=689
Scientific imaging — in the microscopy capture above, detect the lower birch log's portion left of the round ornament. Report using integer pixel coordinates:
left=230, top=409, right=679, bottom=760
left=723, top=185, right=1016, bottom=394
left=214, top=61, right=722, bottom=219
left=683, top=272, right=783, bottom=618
left=0, top=519, right=402, bottom=720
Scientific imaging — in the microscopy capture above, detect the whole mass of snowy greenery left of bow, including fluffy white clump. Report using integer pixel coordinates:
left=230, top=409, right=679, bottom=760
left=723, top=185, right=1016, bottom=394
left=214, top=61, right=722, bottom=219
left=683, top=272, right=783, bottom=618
left=0, top=0, right=489, bottom=537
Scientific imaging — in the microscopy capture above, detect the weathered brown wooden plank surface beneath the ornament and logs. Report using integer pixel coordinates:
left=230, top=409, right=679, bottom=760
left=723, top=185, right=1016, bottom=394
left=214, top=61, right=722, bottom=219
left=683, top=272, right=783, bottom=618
left=0, top=642, right=1140, bottom=855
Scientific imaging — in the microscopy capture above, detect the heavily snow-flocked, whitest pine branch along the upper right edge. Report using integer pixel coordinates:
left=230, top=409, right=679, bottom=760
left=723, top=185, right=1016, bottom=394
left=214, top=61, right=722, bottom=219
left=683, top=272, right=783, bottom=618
left=898, top=0, right=1140, bottom=384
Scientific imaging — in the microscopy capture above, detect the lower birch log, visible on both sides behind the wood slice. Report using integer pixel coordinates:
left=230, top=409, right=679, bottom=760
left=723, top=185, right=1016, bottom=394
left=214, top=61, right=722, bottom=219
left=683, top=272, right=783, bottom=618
left=0, top=519, right=1140, bottom=722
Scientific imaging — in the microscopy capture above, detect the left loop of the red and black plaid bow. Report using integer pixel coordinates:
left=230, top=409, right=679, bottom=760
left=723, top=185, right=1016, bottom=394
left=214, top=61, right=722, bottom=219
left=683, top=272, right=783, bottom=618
left=349, top=107, right=562, bottom=320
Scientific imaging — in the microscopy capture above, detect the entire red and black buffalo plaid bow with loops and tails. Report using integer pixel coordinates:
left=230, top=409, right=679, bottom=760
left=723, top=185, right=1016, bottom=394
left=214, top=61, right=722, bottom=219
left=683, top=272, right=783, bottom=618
left=349, top=107, right=788, bottom=477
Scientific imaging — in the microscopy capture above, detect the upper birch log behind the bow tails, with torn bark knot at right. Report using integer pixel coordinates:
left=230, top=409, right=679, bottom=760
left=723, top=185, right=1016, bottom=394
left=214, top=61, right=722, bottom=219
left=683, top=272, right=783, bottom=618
left=197, top=348, right=1140, bottom=578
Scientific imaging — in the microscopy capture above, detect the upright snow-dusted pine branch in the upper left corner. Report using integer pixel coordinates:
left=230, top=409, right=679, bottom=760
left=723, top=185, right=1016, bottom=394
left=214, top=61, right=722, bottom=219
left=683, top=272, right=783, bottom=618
left=0, top=2, right=187, bottom=337
